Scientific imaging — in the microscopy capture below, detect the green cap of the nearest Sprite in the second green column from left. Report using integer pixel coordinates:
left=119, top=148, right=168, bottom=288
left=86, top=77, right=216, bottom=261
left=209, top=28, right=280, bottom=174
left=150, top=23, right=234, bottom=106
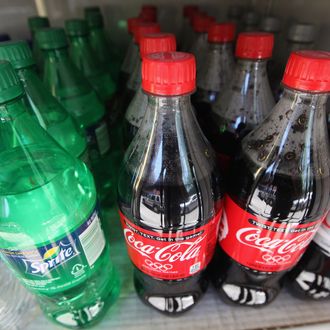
left=36, top=28, right=68, bottom=49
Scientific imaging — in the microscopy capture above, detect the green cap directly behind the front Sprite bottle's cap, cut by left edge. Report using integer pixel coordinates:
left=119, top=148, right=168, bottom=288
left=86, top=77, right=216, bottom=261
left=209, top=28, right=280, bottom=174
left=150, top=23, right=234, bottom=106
left=0, top=40, right=35, bottom=69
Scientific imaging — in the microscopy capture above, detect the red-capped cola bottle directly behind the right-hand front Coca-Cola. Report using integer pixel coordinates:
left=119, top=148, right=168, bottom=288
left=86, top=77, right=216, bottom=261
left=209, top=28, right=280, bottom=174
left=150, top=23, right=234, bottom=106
left=208, top=32, right=275, bottom=170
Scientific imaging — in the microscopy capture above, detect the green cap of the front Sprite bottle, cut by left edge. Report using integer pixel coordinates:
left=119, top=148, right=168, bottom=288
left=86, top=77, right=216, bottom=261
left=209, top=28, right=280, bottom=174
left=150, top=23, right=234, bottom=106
left=0, top=61, right=23, bottom=103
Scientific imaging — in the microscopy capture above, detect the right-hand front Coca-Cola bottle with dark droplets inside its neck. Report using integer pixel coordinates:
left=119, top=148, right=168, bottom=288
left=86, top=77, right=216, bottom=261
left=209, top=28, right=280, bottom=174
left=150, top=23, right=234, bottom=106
left=213, top=51, right=330, bottom=306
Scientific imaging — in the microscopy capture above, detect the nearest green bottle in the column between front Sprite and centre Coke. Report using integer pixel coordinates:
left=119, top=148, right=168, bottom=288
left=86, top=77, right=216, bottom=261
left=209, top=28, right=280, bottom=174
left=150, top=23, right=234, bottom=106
left=36, top=28, right=116, bottom=206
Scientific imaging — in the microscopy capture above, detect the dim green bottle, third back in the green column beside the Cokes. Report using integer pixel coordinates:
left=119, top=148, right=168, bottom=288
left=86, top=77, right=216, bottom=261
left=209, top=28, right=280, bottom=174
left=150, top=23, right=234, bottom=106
left=85, top=11, right=121, bottom=82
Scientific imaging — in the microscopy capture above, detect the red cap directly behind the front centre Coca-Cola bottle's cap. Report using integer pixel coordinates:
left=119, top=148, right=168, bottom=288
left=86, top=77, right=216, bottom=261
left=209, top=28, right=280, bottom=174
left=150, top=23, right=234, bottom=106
left=140, top=33, right=176, bottom=58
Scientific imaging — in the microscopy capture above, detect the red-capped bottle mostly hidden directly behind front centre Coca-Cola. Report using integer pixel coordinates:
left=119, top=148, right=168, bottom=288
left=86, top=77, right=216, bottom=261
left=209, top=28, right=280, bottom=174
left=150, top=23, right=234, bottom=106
left=125, top=33, right=176, bottom=147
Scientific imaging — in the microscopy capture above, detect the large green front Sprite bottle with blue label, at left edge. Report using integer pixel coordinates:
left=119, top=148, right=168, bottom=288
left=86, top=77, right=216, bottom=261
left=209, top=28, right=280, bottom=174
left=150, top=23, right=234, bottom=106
left=0, top=61, right=119, bottom=328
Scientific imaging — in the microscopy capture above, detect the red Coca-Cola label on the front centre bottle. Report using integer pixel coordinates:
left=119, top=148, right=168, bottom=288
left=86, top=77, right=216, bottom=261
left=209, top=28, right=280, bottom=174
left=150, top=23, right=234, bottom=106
left=119, top=211, right=222, bottom=280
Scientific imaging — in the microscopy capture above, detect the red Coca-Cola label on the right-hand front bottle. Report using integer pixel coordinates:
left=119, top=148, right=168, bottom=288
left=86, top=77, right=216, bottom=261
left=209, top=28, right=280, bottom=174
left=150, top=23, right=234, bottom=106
left=219, top=196, right=324, bottom=272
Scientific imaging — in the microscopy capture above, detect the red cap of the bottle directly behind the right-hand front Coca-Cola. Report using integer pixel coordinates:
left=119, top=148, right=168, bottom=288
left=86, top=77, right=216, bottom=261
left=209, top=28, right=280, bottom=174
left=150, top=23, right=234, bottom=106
left=235, top=32, right=274, bottom=59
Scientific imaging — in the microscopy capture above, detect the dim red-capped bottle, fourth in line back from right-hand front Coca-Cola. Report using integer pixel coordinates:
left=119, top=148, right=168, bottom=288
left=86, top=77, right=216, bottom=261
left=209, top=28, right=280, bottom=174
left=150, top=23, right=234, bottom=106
left=189, top=13, right=215, bottom=72
